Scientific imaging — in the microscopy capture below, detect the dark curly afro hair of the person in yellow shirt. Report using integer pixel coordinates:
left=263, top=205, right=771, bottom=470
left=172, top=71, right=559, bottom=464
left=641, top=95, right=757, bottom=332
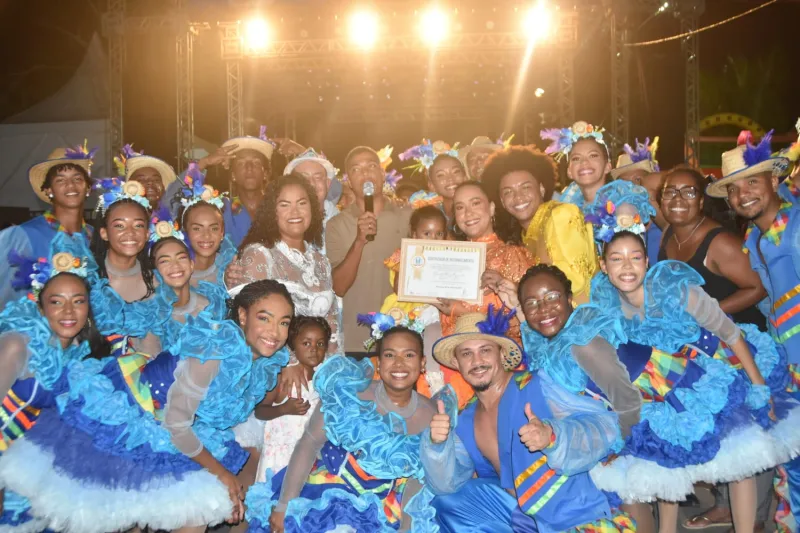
left=481, top=146, right=558, bottom=244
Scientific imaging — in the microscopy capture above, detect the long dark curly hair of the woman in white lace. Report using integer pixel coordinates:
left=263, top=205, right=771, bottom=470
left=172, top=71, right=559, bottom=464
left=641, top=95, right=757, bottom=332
left=239, top=173, right=322, bottom=253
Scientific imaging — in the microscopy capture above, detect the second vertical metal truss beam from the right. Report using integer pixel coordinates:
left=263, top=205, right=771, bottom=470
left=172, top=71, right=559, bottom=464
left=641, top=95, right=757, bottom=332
left=607, top=6, right=630, bottom=158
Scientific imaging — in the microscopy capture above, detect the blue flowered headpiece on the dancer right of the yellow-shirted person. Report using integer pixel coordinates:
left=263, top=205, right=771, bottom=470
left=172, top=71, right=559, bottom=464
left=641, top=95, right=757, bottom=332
left=586, top=180, right=656, bottom=243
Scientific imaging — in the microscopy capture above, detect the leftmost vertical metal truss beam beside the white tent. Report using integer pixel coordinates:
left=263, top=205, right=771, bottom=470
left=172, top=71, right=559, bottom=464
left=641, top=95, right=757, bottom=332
left=103, top=0, right=125, bottom=158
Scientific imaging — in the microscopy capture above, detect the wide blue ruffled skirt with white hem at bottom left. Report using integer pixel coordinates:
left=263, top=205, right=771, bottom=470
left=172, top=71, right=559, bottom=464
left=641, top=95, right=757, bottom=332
left=0, top=354, right=247, bottom=533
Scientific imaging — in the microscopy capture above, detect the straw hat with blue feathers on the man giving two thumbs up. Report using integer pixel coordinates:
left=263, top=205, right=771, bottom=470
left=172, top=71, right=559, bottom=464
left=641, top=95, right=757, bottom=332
left=433, top=305, right=522, bottom=371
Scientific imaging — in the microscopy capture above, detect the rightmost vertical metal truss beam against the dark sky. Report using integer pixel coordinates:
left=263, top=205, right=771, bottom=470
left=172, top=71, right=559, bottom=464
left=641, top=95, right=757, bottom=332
left=680, top=0, right=704, bottom=168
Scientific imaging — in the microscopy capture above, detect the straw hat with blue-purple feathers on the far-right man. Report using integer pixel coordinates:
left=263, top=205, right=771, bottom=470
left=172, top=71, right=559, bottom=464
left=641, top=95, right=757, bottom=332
left=706, top=131, right=788, bottom=198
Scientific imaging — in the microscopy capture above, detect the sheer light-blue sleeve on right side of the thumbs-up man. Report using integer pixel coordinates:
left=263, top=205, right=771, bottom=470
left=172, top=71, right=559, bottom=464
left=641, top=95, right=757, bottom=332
left=539, top=373, right=623, bottom=475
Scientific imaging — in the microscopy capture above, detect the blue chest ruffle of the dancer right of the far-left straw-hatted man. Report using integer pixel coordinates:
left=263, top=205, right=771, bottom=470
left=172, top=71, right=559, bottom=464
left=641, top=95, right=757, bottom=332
left=90, top=278, right=177, bottom=337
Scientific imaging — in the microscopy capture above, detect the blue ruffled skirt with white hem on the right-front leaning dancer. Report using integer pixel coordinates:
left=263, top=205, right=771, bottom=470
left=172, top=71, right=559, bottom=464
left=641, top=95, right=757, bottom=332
left=591, top=340, right=793, bottom=502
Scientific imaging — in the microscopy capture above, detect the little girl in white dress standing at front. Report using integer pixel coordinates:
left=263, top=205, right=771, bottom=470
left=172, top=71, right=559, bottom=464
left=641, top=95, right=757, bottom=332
left=255, top=315, right=331, bottom=481
